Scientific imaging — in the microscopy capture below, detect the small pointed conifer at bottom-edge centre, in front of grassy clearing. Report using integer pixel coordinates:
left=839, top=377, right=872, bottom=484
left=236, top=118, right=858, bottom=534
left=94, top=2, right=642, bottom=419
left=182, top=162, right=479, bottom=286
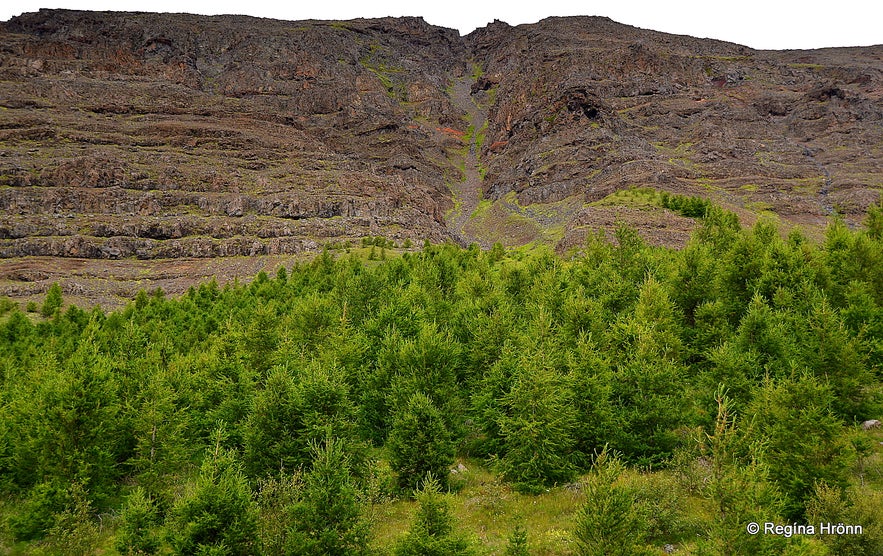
left=395, top=474, right=475, bottom=556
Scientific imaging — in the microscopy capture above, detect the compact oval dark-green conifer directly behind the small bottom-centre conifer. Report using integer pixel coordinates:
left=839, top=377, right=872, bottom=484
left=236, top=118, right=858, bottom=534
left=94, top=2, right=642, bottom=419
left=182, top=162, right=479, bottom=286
left=387, top=393, right=454, bottom=489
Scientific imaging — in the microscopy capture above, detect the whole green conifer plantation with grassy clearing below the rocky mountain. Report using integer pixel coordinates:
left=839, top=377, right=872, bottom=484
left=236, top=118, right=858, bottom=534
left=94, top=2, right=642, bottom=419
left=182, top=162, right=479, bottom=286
left=0, top=202, right=883, bottom=555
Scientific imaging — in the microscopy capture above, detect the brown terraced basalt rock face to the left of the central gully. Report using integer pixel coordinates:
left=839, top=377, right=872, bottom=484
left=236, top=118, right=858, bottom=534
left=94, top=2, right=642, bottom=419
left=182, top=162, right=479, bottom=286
left=0, top=10, right=465, bottom=258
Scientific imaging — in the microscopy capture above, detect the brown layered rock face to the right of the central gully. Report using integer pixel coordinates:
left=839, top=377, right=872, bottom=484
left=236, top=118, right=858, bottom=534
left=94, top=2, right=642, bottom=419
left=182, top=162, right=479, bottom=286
left=467, top=18, right=883, bottom=229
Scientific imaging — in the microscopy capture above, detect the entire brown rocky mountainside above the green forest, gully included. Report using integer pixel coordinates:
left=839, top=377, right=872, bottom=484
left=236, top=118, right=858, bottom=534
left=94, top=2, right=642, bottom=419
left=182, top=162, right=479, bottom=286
left=0, top=10, right=883, bottom=304
